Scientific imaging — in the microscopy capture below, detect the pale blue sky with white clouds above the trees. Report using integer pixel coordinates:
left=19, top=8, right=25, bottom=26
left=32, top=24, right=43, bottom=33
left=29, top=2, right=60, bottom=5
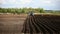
left=0, top=0, right=60, bottom=10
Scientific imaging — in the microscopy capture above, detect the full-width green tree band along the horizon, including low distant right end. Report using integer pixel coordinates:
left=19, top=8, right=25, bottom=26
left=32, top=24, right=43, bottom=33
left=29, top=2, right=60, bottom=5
left=0, top=8, right=60, bottom=14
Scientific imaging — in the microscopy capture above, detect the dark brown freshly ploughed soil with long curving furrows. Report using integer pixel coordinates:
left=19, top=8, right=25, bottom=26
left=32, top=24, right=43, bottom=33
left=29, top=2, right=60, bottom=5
left=22, top=15, right=60, bottom=34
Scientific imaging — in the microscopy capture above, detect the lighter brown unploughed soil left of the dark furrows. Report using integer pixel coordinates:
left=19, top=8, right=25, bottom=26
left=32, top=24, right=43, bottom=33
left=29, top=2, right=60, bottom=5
left=0, top=15, right=26, bottom=34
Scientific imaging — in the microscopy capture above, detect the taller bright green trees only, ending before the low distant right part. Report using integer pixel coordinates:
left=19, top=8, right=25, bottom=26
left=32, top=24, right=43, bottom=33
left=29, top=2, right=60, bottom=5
left=0, top=8, right=44, bottom=14
